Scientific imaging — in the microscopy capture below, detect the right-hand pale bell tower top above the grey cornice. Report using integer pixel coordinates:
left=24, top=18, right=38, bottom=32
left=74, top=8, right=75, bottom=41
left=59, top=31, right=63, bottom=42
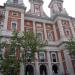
left=49, top=0, right=67, bottom=16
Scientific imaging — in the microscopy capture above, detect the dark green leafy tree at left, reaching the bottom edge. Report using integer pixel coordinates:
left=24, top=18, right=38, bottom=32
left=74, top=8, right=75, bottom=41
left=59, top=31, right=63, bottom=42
left=3, top=31, right=20, bottom=75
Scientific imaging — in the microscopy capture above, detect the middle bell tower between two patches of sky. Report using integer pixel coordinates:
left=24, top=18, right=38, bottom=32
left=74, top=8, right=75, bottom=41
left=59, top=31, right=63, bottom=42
left=29, top=0, right=46, bottom=17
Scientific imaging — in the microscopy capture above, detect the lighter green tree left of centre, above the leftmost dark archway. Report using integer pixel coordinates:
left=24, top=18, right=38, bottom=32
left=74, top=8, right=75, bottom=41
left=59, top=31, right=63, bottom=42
left=21, top=31, right=45, bottom=74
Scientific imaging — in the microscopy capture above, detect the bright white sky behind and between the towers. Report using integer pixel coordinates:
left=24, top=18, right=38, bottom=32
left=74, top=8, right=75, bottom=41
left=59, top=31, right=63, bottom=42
left=0, top=0, right=75, bottom=17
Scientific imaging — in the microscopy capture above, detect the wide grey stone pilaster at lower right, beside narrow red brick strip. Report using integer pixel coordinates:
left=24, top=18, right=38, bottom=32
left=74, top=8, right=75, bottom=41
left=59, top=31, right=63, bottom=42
left=64, top=50, right=74, bottom=75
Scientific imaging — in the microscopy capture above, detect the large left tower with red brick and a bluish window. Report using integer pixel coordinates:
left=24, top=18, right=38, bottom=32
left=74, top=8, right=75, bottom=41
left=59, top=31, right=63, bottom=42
left=4, top=0, right=26, bottom=32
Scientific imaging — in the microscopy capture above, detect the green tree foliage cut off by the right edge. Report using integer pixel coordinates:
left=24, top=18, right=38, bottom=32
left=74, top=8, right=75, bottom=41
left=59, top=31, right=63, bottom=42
left=65, top=38, right=75, bottom=55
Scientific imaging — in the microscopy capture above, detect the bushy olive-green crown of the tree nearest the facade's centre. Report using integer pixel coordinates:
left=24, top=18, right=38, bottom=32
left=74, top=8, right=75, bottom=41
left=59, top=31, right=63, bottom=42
left=21, top=32, right=44, bottom=60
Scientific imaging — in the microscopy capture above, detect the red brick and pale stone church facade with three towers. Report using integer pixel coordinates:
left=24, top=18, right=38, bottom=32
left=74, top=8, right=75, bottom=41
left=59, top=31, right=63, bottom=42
left=0, top=0, right=75, bottom=75
